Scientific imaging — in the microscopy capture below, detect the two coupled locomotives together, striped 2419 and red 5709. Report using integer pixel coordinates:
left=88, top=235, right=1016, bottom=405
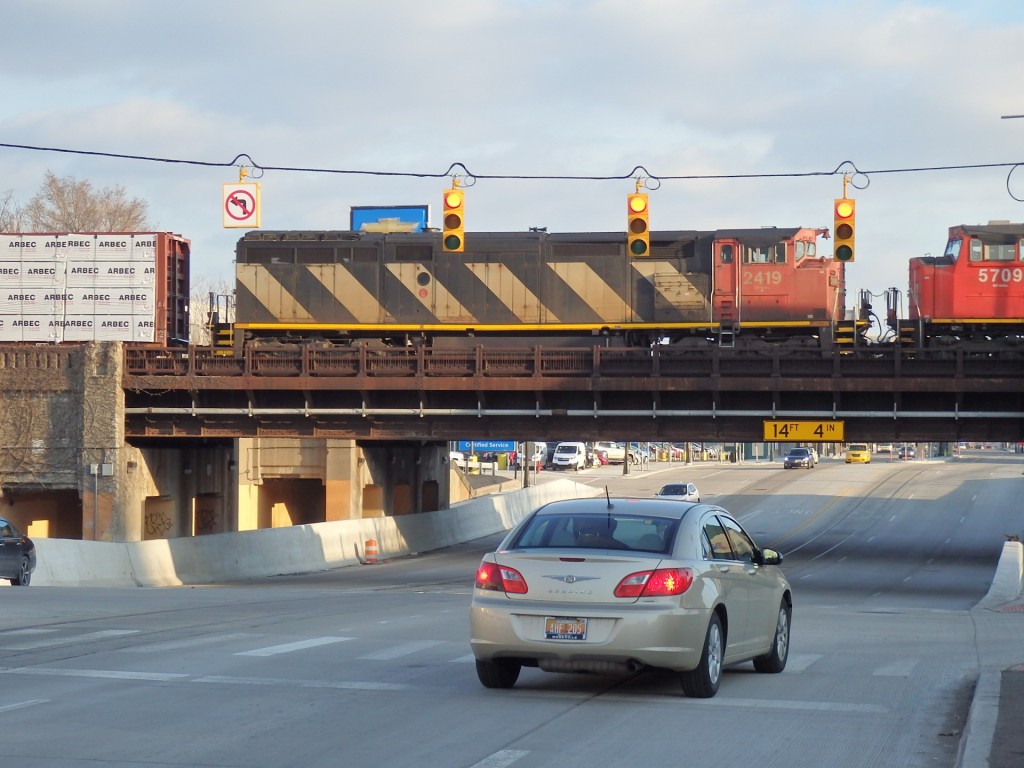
left=219, top=223, right=1024, bottom=351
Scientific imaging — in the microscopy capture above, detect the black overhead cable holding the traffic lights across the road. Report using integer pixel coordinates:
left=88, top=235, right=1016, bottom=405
left=0, top=142, right=1021, bottom=181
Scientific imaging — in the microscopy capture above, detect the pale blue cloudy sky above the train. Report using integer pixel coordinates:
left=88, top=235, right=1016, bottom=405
left=0, top=0, right=1024, bottom=306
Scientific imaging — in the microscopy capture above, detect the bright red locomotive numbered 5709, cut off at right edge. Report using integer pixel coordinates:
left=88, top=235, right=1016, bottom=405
left=884, top=222, right=1024, bottom=351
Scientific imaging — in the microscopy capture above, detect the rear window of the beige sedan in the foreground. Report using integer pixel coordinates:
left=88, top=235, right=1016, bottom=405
left=511, top=514, right=679, bottom=554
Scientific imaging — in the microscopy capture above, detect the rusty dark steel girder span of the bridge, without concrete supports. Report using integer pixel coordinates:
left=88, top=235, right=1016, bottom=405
left=123, top=345, right=1024, bottom=441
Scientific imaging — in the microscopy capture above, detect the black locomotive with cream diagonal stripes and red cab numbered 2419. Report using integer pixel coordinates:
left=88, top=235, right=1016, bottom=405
left=228, top=227, right=853, bottom=347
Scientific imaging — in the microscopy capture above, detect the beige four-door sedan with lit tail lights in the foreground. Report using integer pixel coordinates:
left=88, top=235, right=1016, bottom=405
left=470, top=497, right=793, bottom=698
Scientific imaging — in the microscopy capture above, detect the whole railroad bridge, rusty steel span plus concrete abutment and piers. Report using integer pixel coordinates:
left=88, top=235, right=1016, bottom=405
left=0, top=342, right=1024, bottom=542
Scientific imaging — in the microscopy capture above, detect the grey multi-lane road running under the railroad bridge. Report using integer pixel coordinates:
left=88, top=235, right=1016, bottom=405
left=0, top=455, right=1024, bottom=768
